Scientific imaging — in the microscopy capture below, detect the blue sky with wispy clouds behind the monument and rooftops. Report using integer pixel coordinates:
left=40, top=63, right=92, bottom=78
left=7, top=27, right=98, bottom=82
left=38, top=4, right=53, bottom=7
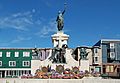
left=0, top=0, right=120, bottom=48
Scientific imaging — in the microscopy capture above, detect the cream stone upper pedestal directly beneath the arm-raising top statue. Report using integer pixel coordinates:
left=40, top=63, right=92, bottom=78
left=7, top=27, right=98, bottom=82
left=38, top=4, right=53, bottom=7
left=51, top=31, right=69, bottom=48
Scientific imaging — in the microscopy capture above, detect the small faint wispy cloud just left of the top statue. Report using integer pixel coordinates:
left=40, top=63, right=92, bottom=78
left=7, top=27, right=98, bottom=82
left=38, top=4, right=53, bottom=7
left=36, top=19, right=57, bottom=37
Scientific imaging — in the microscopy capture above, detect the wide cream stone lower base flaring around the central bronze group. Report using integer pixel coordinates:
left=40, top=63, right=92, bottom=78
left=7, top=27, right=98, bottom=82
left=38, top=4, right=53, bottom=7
left=31, top=49, right=79, bottom=75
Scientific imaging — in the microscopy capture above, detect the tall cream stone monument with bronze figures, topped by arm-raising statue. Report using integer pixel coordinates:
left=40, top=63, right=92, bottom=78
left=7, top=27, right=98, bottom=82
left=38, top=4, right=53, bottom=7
left=31, top=3, right=83, bottom=74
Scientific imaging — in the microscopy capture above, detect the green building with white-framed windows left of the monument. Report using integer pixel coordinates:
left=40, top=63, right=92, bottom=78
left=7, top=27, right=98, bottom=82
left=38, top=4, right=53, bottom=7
left=0, top=48, right=32, bottom=78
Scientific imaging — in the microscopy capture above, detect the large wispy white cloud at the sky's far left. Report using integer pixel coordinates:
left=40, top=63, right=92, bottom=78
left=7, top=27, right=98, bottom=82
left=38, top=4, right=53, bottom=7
left=0, top=9, right=35, bottom=31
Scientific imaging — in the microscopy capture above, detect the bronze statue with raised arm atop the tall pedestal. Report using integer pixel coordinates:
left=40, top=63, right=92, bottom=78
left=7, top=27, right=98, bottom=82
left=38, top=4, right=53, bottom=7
left=56, top=4, right=66, bottom=31
